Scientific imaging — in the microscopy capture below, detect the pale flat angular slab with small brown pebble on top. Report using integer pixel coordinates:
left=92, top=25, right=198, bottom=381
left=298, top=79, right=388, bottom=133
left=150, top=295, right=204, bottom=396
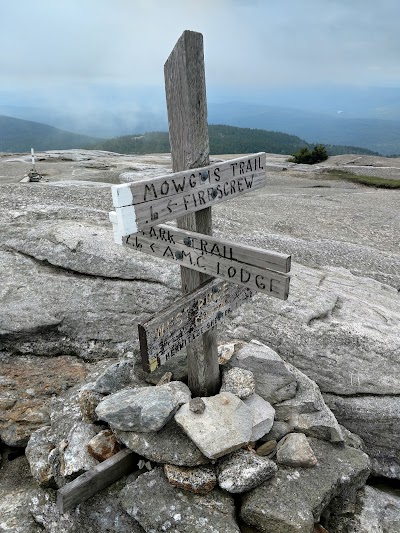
left=175, top=392, right=253, bottom=459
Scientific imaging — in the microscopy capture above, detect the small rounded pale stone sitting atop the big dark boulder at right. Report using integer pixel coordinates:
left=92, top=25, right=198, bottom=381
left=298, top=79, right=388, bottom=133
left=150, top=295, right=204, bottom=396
left=276, top=433, right=317, bottom=468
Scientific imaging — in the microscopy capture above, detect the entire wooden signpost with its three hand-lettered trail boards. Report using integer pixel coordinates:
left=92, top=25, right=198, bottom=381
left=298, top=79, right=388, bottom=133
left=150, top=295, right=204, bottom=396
left=110, top=31, right=290, bottom=396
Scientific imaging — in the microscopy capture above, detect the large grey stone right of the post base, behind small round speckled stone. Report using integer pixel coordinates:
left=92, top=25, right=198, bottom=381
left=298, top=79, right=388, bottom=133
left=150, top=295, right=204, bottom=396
left=225, top=343, right=296, bottom=404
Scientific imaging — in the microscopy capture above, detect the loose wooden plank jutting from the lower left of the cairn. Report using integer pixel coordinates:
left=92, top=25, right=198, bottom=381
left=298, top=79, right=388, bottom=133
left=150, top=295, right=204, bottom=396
left=57, top=449, right=139, bottom=514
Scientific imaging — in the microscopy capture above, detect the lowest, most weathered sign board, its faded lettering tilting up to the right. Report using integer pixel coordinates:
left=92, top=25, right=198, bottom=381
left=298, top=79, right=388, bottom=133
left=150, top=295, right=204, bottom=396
left=138, top=280, right=254, bottom=372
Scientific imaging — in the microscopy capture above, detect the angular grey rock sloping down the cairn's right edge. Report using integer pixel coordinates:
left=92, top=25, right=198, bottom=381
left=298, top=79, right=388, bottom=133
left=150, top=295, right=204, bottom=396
left=275, top=363, right=344, bottom=442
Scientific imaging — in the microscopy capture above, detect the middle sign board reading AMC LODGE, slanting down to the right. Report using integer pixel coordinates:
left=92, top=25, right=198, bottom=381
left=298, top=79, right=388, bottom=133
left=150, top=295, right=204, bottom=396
left=110, top=216, right=290, bottom=300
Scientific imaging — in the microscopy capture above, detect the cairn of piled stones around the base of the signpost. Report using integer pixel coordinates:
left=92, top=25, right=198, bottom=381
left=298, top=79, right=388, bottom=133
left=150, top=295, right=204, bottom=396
left=22, top=341, right=383, bottom=533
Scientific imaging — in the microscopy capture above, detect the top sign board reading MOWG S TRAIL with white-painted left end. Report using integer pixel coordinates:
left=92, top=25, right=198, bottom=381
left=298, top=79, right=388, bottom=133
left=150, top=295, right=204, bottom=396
left=111, top=152, right=266, bottom=233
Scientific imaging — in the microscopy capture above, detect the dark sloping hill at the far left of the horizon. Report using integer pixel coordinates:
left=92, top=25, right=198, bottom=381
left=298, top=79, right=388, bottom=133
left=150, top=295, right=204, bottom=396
left=0, top=115, right=99, bottom=152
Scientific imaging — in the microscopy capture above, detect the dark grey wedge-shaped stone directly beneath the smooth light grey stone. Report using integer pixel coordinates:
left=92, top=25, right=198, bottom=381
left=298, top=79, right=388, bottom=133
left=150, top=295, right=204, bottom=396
left=114, top=419, right=209, bottom=466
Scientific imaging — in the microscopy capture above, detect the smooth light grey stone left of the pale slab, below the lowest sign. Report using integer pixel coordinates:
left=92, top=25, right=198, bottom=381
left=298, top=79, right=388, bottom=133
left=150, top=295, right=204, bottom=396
left=96, top=381, right=191, bottom=432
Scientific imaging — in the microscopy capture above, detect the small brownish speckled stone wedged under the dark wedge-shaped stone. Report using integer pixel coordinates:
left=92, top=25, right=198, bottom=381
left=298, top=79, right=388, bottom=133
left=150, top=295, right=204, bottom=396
left=164, top=465, right=217, bottom=494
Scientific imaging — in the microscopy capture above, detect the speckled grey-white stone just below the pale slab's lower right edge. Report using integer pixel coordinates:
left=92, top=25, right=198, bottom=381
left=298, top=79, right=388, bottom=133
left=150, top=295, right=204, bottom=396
left=217, top=450, right=278, bottom=494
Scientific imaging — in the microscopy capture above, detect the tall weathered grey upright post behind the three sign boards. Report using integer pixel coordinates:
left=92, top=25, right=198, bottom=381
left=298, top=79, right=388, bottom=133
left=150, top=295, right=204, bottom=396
left=164, top=30, right=220, bottom=396
